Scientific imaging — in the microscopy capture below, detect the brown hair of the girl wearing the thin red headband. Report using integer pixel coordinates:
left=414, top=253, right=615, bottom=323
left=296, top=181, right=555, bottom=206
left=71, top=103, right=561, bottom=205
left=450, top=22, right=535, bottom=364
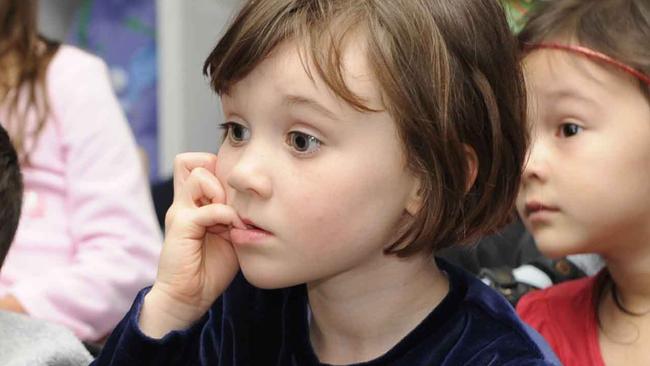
left=519, top=0, right=650, bottom=329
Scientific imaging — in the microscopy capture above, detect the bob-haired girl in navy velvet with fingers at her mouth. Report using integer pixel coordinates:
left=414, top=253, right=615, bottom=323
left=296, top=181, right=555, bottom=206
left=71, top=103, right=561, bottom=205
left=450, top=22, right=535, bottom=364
left=95, top=0, right=554, bottom=366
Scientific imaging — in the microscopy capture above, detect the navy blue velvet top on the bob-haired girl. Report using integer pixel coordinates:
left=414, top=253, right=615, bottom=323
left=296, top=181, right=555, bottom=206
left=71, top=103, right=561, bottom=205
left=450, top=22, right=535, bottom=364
left=93, top=259, right=560, bottom=366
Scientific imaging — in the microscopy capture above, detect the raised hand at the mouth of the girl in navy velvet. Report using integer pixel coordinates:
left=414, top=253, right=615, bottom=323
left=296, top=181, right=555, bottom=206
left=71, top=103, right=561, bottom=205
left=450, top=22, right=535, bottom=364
left=139, top=153, right=245, bottom=338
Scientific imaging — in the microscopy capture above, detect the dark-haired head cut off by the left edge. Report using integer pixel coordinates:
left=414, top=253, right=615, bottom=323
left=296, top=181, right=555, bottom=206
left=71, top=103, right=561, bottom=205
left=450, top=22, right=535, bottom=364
left=0, top=126, right=23, bottom=267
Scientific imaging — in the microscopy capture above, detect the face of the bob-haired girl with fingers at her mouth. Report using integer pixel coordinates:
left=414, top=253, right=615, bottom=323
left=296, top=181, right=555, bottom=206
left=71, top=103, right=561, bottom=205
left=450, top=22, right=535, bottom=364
left=216, top=43, right=418, bottom=288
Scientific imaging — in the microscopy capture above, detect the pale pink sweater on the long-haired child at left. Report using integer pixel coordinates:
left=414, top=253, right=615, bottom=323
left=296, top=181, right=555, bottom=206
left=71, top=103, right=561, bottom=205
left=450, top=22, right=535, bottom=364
left=0, top=46, right=162, bottom=340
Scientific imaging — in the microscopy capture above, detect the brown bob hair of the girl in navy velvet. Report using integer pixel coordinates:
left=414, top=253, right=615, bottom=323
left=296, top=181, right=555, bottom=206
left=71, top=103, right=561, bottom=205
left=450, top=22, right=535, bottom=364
left=203, top=0, right=528, bottom=256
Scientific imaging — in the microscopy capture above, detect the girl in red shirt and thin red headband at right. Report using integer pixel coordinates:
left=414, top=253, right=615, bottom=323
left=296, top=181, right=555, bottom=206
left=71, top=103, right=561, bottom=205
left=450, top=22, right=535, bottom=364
left=517, top=0, right=650, bottom=366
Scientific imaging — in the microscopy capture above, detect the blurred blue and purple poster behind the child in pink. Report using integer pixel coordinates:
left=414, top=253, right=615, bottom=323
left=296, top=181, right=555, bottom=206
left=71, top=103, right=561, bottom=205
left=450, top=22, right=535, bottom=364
left=67, top=0, right=158, bottom=179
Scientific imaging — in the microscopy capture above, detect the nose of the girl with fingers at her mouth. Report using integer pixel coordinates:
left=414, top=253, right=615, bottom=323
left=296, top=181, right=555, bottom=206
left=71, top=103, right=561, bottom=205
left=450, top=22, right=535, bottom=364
left=227, top=146, right=273, bottom=199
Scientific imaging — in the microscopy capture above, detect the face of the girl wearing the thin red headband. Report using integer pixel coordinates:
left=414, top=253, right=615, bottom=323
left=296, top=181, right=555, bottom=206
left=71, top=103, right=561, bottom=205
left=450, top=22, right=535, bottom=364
left=517, top=50, right=650, bottom=257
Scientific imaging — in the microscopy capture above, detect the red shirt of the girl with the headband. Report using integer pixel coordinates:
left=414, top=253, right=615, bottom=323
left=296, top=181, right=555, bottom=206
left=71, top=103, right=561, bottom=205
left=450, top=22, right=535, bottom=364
left=517, top=276, right=605, bottom=366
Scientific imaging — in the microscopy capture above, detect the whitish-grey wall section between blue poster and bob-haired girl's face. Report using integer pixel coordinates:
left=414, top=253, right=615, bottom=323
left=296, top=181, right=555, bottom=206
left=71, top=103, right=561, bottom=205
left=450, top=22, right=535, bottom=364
left=157, top=0, right=238, bottom=176
